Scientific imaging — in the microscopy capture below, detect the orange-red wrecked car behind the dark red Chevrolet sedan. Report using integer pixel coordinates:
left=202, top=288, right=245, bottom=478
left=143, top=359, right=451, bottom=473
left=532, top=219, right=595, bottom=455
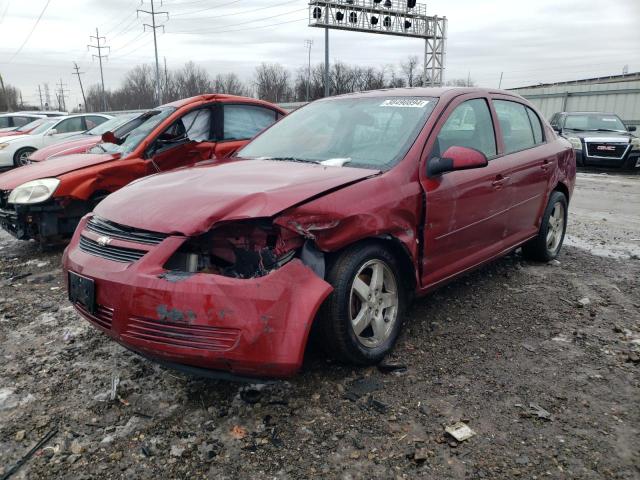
left=0, top=95, right=286, bottom=246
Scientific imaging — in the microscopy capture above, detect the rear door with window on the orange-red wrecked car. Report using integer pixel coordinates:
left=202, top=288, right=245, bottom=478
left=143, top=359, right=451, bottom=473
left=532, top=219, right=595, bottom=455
left=215, top=103, right=282, bottom=158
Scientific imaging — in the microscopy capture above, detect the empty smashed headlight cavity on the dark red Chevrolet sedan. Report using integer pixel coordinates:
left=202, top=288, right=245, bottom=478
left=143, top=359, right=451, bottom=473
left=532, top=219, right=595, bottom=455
left=164, top=219, right=304, bottom=278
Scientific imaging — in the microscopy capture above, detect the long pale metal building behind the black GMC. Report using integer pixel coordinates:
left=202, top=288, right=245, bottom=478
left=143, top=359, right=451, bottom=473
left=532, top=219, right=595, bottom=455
left=511, top=72, right=640, bottom=125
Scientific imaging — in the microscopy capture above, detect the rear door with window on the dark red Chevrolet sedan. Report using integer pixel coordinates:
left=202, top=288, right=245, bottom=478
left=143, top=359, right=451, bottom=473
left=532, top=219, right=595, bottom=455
left=492, top=97, right=558, bottom=244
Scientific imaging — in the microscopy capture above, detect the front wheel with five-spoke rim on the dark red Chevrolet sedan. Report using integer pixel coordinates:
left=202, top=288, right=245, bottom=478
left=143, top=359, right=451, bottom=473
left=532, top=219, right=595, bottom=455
left=318, top=243, right=407, bottom=365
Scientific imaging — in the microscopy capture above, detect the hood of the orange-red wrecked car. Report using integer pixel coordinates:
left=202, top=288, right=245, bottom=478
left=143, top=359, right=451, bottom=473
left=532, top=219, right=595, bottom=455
left=0, top=153, right=119, bottom=190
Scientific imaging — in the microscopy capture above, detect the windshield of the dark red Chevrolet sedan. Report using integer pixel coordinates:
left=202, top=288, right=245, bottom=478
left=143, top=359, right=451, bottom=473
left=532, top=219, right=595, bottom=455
left=238, top=97, right=437, bottom=170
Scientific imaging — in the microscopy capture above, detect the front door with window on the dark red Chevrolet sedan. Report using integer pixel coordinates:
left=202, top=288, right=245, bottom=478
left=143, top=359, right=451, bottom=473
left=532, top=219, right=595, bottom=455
left=421, top=95, right=510, bottom=287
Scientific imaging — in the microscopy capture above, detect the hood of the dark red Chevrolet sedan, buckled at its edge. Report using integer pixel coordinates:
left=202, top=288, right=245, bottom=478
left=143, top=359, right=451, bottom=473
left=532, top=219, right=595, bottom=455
left=96, top=160, right=379, bottom=236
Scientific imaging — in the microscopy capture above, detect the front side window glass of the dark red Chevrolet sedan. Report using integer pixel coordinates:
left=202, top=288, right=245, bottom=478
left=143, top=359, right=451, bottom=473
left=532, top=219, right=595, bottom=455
left=431, top=98, right=497, bottom=158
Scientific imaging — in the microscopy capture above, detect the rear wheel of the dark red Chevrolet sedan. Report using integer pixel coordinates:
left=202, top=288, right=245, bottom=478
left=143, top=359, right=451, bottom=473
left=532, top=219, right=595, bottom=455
left=522, top=191, right=568, bottom=262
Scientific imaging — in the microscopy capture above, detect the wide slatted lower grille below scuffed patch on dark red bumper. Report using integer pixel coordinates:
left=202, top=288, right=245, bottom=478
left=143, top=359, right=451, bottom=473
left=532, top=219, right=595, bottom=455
left=123, top=317, right=240, bottom=352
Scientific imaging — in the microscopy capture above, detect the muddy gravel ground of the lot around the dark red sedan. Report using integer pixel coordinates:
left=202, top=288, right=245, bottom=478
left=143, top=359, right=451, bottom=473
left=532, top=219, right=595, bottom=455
left=0, top=173, right=640, bottom=479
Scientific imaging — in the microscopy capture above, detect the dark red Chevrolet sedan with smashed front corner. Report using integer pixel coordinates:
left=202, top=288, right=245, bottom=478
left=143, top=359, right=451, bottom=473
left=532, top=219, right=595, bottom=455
left=63, top=88, right=575, bottom=377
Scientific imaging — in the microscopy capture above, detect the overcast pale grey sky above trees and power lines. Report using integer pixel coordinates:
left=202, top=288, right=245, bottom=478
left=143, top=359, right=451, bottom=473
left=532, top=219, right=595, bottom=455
left=0, top=0, right=640, bottom=105
